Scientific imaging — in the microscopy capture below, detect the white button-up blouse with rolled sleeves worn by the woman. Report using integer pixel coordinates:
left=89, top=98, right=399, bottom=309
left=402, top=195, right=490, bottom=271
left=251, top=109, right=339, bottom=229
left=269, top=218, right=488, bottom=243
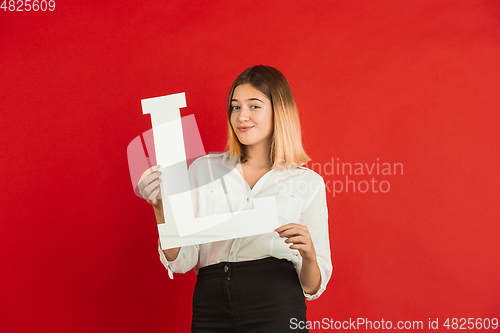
left=158, top=152, right=332, bottom=301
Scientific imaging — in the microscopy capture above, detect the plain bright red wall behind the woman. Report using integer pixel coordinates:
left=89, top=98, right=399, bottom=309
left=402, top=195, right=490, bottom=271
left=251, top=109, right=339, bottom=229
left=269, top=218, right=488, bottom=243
left=0, top=0, right=500, bottom=332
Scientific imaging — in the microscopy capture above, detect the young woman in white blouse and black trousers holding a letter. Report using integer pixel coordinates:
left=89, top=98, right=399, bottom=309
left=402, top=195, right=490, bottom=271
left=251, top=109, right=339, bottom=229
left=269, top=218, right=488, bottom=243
left=138, top=66, right=332, bottom=333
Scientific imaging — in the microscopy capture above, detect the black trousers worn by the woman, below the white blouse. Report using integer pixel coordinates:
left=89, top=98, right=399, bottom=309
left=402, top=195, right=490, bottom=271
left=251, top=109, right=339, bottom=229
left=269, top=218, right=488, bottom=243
left=191, top=257, right=308, bottom=333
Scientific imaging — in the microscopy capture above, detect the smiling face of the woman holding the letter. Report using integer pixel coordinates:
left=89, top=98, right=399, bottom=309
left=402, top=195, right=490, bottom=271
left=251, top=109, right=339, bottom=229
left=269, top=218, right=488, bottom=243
left=231, top=83, right=274, bottom=146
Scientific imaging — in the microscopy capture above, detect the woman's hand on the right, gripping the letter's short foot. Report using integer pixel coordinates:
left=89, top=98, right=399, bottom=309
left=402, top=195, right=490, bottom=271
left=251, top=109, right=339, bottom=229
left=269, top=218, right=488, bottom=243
left=274, top=223, right=316, bottom=261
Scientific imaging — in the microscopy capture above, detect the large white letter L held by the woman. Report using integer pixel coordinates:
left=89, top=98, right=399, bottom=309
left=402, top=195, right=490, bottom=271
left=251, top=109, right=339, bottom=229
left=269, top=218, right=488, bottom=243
left=141, top=93, right=279, bottom=250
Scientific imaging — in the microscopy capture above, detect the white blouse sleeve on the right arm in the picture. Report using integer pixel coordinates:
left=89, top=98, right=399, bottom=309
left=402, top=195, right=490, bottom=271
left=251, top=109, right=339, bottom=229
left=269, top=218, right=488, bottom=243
left=296, top=175, right=333, bottom=301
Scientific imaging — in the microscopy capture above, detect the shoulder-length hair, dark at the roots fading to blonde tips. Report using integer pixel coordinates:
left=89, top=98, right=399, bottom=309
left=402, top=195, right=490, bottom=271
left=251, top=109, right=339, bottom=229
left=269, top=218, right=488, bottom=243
left=226, top=65, right=311, bottom=169
